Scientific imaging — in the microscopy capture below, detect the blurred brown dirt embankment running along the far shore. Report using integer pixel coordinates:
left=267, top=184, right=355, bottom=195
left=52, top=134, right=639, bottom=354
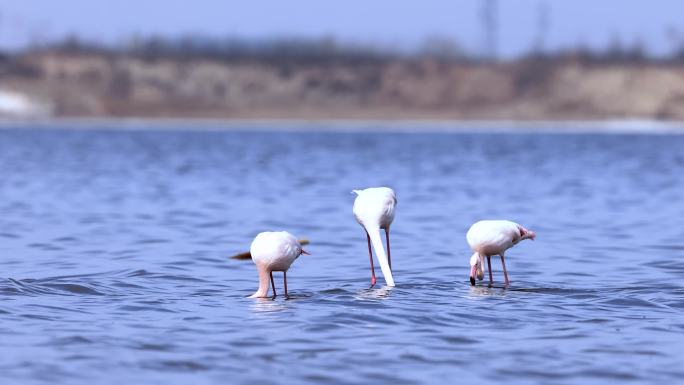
left=0, top=53, right=684, bottom=120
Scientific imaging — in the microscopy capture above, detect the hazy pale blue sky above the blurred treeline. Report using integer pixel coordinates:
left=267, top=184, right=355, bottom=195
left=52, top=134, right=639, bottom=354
left=0, top=0, right=684, bottom=56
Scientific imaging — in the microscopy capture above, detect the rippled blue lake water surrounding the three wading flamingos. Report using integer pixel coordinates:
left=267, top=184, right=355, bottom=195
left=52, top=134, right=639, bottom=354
left=0, top=127, right=684, bottom=385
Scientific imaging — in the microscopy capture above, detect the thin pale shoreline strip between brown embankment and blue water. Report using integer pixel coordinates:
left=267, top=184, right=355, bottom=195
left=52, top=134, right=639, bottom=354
left=0, top=118, right=684, bottom=134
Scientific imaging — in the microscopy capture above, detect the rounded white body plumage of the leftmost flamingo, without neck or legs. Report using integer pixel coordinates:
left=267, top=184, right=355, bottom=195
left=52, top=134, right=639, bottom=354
left=249, top=231, right=302, bottom=271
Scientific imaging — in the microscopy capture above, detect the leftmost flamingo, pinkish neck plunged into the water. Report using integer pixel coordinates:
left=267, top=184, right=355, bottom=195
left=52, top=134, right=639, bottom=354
left=249, top=231, right=309, bottom=298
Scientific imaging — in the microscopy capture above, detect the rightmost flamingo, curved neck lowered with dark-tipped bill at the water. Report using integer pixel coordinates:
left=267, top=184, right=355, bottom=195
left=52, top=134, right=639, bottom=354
left=466, top=220, right=537, bottom=286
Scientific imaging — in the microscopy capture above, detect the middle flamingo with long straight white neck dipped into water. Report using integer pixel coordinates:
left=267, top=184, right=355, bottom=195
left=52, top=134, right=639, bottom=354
left=353, top=187, right=397, bottom=286
